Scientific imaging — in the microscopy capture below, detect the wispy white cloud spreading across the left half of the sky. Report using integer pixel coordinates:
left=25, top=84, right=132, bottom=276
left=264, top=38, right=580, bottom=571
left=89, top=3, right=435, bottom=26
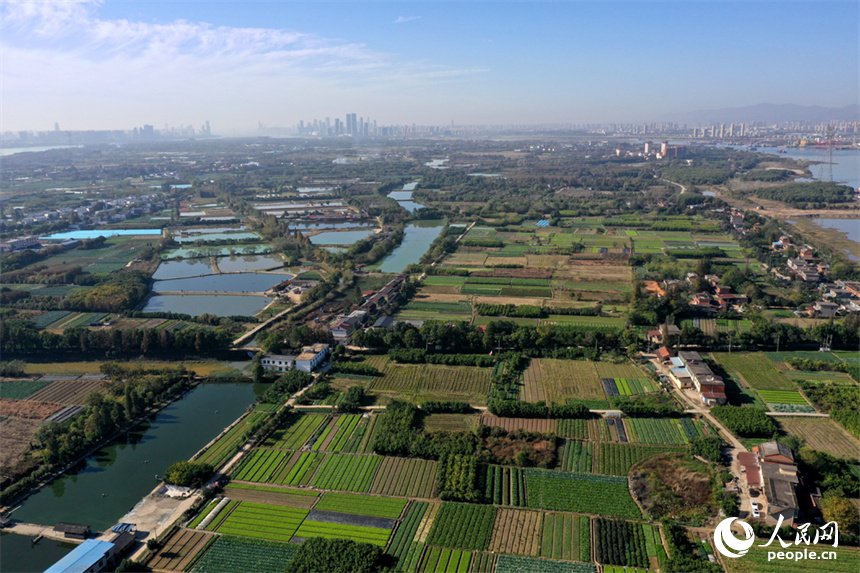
left=0, top=0, right=485, bottom=130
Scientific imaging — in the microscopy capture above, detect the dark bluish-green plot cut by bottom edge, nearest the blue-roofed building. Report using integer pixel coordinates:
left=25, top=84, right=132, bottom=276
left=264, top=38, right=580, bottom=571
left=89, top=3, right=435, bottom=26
left=190, top=535, right=299, bottom=573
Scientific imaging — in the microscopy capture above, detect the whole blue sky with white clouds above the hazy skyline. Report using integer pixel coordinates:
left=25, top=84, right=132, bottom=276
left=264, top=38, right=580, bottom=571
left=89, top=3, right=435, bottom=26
left=0, top=0, right=860, bottom=134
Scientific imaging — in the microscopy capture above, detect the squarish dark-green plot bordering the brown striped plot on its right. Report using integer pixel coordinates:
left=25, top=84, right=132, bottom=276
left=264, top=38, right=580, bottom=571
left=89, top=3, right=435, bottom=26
left=427, top=502, right=496, bottom=551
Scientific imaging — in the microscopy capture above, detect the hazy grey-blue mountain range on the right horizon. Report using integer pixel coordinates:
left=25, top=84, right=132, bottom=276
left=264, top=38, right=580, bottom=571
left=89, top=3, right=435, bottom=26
left=665, top=103, right=860, bottom=124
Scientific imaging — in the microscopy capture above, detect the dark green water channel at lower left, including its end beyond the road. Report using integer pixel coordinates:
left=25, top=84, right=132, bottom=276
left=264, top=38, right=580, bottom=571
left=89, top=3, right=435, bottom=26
left=0, top=383, right=262, bottom=572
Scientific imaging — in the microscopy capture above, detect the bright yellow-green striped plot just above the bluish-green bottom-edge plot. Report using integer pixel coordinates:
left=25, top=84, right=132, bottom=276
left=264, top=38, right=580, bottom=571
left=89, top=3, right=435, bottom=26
left=215, top=501, right=308, bottom=543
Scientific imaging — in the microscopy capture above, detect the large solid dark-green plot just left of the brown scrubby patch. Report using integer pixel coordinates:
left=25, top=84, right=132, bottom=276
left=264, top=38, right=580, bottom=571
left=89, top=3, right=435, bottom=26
left=525, top=468, right=642, bottom=518
